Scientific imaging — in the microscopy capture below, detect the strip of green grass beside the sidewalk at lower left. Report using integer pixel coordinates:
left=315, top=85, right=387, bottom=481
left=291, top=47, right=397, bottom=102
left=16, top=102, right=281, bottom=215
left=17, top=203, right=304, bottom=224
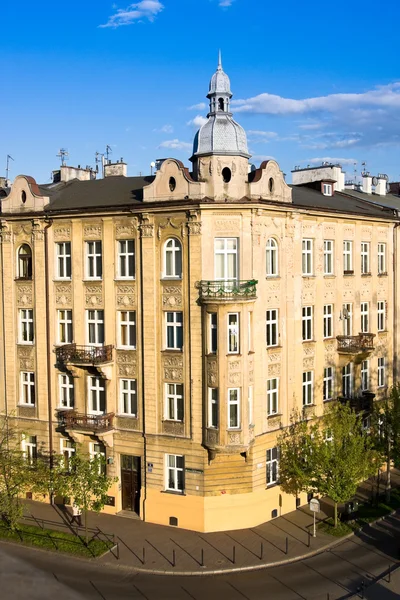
left=0, top=523, right=113, bottom=558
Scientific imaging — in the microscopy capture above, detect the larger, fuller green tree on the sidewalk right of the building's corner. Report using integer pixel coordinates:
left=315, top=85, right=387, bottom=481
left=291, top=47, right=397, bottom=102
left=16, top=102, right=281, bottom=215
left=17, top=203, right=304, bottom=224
left=312, top=402, right=376, bottom=527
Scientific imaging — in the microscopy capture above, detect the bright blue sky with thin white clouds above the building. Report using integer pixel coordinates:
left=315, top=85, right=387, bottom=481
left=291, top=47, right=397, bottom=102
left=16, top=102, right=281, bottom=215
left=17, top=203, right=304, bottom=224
left=0, top=0, right=400, bottom=183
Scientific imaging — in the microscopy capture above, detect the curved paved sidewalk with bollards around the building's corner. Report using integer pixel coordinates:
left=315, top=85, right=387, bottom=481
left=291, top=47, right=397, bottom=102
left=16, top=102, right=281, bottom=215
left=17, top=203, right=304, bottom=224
left=18, top=500, right=343, bottom=575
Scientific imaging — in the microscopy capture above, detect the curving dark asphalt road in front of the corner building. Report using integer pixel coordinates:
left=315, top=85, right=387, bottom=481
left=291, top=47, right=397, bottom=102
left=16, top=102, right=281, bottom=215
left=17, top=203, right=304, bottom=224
left=0, top=516, right=400, bottom=600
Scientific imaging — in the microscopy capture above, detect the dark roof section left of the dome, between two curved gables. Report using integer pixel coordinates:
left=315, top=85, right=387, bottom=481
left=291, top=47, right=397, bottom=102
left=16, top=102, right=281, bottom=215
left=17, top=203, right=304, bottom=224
left=40, top=176, right=154, bottom=211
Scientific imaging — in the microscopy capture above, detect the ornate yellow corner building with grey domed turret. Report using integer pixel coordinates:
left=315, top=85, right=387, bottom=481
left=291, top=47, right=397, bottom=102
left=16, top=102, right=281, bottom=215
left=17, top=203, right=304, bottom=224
left=0, top=58, right=400, bottom=531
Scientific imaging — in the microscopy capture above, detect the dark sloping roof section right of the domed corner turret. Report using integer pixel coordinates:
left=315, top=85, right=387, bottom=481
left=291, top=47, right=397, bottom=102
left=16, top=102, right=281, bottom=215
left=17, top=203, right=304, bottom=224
left=290, top=185, right=396, bottom=219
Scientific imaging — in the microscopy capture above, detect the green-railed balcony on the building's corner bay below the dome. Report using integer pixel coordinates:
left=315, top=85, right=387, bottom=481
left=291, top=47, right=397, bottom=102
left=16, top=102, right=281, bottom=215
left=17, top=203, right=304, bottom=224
left=196, top=279, right=258, bottom=302
